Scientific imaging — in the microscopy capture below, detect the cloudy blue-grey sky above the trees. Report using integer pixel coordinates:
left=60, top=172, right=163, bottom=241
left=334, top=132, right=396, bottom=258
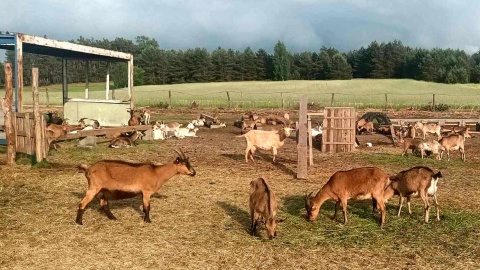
left=0, top=0, right=480, bottom=60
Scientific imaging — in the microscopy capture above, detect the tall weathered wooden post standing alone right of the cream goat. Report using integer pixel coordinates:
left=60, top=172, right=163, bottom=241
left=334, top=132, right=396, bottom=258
left=297, top=95, right=308, bottom=179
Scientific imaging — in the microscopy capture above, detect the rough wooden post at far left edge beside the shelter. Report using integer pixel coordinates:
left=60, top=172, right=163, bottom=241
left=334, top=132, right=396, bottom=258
left=2, top=63, right=17, bottom=165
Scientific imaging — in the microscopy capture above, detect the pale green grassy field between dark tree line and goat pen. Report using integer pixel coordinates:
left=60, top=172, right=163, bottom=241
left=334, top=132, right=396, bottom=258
left=0, top=79, right=480, bottom=111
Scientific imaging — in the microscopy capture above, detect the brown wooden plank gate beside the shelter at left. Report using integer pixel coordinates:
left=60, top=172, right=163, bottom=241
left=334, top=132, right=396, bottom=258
left=13, top=112, right=48, bottom=158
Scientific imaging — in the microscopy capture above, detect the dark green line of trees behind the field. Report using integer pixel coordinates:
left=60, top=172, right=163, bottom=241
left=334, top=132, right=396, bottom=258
left=0, top=36, right=480, bottom=87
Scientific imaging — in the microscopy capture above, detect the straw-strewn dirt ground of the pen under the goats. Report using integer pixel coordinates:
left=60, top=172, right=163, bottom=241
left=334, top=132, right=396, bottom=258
left=0, top=109, right=480, bottom=269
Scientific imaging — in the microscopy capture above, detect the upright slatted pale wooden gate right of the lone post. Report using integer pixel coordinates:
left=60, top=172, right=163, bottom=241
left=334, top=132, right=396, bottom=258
left=322, top=107, right=357, bottom=153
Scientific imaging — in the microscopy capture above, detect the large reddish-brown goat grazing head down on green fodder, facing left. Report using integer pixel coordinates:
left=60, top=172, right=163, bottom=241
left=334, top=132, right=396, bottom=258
left=305, top=167, right=390, bottom=226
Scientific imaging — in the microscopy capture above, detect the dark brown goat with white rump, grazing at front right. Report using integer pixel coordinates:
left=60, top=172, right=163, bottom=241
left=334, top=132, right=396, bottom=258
left=384, top=166, right=443, bottom=223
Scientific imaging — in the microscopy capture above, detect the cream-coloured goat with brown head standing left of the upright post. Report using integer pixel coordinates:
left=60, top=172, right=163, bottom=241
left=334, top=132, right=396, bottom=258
left=237, top=127, right=291, bottom=163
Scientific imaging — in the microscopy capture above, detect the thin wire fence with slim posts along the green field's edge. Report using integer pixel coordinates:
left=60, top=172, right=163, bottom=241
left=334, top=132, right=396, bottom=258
left=0, top=87, right=480, bottom=111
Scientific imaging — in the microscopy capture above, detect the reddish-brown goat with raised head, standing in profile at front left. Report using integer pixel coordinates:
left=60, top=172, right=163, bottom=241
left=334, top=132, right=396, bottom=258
left=76, top=150, right=196, bottom=225
